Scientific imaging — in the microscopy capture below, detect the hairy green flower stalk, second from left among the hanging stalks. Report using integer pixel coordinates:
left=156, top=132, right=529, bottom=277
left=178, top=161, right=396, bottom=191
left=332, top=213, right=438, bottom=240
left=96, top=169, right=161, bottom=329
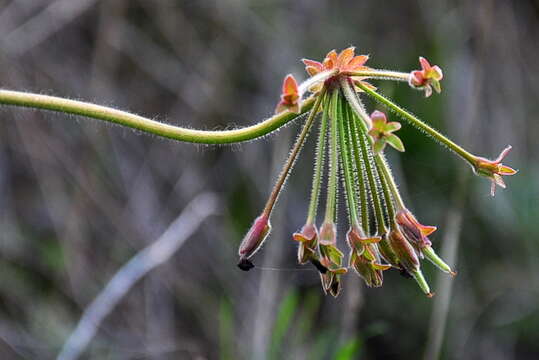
left=306, top=96, right=329, bottom=224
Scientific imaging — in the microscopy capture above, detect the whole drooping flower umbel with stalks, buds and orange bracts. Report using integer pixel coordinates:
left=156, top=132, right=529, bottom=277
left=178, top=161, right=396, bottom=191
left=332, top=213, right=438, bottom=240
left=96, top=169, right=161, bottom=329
left=238, top=47, right=516, bottom=297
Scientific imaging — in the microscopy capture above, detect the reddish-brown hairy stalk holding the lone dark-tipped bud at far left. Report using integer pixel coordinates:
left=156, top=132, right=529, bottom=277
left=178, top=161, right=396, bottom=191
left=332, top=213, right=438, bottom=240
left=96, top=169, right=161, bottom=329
left=263, top=90, right=324, bottom=217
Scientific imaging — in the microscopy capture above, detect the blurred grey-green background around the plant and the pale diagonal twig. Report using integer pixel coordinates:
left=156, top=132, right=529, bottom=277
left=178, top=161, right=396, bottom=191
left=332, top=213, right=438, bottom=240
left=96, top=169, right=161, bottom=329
left=0, top=0, right=539, bottom=360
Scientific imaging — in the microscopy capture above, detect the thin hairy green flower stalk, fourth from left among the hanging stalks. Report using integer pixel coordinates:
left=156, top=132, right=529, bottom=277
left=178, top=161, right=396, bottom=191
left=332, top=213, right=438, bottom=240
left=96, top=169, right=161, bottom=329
left=338, top=96, right=362, bottom=230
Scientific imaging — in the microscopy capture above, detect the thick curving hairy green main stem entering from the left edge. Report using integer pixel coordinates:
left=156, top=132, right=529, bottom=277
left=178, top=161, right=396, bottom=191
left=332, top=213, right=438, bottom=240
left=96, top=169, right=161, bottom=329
left=0, top=90, right=316, bottom=144
